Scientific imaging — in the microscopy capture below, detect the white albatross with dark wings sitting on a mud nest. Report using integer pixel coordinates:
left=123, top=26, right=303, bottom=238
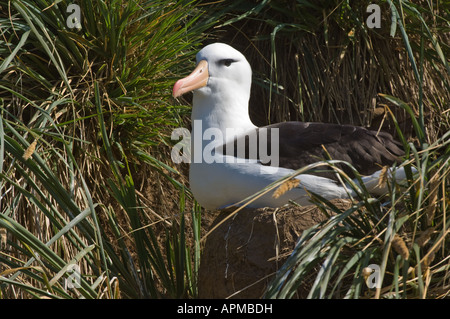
left=173, top=43, right=405, bottom=210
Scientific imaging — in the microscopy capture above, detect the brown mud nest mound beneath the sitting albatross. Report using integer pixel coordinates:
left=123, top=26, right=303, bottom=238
left=198, top=200, right=351, bottom=298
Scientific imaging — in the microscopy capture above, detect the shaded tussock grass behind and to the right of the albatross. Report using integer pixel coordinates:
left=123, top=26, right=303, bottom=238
left=215, top=1, right=450, bottom=298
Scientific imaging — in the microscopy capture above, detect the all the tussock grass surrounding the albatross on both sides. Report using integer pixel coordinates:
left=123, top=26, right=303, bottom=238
left=0, top=0, right=450, bottom=298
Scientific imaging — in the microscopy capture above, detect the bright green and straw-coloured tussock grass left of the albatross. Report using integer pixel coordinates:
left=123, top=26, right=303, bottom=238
left=0, top=0, right=209, bottom=298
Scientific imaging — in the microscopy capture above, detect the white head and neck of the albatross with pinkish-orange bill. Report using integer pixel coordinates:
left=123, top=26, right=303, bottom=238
left=173, top=43, right=255, bottom=143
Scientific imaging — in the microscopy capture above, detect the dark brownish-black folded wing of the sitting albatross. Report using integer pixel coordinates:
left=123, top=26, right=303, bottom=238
left=221, top=122, right=404, bottom=179
